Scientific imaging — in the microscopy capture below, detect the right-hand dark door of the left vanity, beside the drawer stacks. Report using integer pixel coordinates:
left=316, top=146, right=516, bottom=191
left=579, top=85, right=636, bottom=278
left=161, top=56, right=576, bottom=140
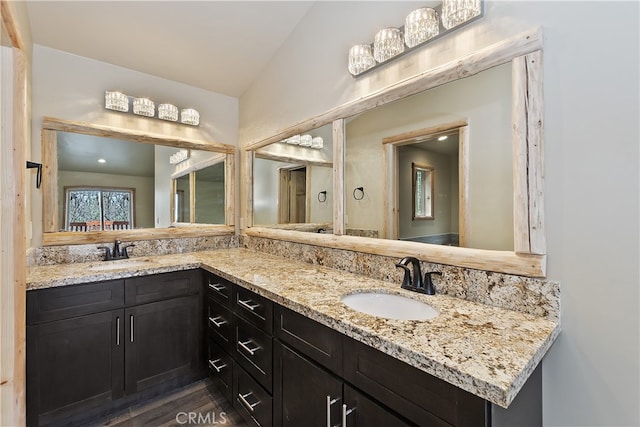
left=125, top=295, right=202, bottom=394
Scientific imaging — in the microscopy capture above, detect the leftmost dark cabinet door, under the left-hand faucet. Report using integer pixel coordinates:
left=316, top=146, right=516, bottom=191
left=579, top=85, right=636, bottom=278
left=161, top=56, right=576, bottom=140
left=27, top=310, right=124, bottom=425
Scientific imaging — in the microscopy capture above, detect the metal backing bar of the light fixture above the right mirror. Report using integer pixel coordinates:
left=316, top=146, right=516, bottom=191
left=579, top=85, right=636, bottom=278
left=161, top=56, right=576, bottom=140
left=349, top=0, right=484, bottom=78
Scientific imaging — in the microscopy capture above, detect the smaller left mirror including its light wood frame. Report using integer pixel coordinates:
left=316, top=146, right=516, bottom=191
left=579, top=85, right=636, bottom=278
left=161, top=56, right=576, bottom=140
left=42, top=117, right=235, bottom=246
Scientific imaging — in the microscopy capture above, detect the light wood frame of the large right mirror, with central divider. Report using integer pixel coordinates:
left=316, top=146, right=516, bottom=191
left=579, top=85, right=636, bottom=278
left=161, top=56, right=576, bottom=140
left=241, top=28, right=546, bottom=277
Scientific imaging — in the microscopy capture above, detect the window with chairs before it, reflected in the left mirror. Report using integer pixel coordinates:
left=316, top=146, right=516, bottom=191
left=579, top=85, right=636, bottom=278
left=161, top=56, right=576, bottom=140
left=64, top=187, right=135, bottom=231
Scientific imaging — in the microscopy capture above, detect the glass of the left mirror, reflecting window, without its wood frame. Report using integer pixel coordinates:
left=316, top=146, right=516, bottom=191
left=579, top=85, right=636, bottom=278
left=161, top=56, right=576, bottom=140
left=57, top=132, right=225, bottom=231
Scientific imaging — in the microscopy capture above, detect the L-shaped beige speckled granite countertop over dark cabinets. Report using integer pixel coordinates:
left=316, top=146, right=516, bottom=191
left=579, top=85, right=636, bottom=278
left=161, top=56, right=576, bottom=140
left=27, top=249, right=560, bottom=408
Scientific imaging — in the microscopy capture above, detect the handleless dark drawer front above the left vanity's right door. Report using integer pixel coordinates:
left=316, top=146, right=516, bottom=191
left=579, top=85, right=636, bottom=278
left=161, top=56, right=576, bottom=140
left=124, top=270, right=200, bottom=306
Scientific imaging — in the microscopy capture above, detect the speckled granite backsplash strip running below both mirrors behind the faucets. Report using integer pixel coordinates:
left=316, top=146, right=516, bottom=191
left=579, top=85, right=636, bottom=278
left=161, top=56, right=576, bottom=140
left=27, top=235, right=560, bottom=322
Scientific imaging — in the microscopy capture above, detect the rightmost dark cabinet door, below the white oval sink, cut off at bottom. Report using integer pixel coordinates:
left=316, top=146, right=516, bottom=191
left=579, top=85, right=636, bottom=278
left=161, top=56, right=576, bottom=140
left=342, top=384, right=415, bottom=427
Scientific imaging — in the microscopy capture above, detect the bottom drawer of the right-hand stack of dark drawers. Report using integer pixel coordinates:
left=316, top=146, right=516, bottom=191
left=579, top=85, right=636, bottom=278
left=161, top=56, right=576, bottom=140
left=232, top=364, right=272, bottom=427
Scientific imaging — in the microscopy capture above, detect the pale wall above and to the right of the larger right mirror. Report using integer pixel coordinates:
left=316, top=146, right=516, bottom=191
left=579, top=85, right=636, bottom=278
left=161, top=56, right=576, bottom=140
left=240, top=1, right=640, bottom=426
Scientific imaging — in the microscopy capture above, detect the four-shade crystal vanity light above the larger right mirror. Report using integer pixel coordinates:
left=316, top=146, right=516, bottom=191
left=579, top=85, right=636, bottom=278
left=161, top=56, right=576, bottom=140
left=348, top=0, right=484, bottom=77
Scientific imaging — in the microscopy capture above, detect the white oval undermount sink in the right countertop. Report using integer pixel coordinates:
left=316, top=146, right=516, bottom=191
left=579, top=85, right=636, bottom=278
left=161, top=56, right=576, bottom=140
left=340, top=292, right=440, bottom=320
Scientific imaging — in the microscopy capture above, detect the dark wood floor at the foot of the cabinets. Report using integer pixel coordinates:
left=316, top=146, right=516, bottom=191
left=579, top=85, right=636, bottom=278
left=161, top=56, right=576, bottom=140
left=89, top=380, right=246, bottom=427
